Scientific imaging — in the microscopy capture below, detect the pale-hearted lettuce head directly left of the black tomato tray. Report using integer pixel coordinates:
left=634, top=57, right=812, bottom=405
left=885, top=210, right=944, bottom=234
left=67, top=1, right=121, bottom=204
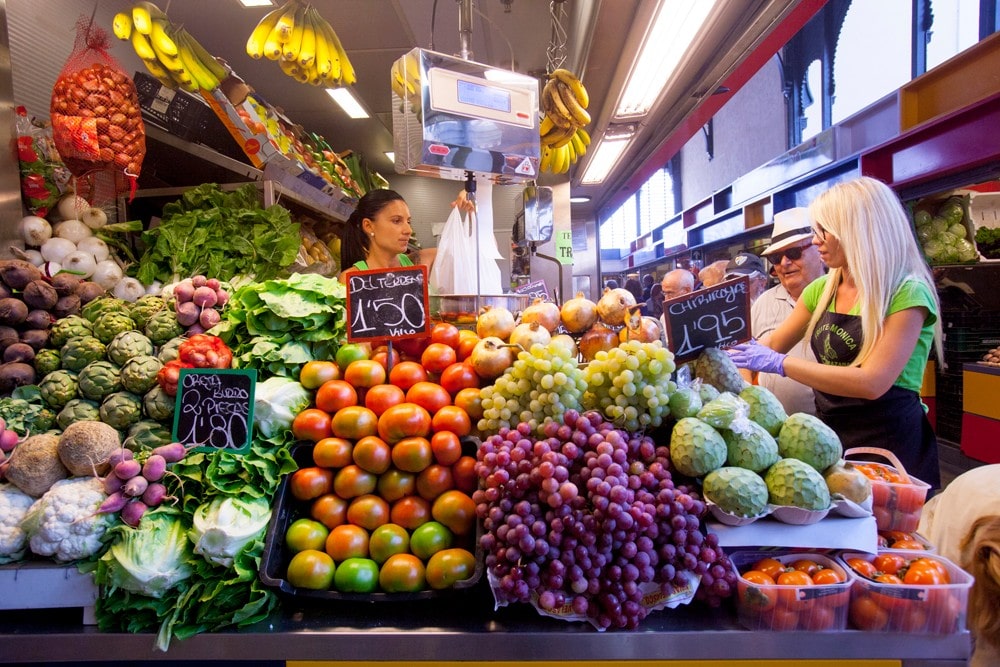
left=188, top=496, right=271, bottom=567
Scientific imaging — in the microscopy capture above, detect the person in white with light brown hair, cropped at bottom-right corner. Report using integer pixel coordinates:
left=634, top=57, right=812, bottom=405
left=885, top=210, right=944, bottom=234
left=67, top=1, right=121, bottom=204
left=917, top=464, right=1000, bottom=667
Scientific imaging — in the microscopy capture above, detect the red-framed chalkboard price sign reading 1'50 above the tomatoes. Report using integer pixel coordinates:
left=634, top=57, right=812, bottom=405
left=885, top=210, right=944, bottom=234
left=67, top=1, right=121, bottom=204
left=347, top=266, right=430, bottom=343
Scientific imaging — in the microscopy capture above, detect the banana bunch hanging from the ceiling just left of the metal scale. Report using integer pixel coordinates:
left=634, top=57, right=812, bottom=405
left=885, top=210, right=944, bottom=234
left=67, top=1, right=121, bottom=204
left=247, top=0, right=358, bottom=88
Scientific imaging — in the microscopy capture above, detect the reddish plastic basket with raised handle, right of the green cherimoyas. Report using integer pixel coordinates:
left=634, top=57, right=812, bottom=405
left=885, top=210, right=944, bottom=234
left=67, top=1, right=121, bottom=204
left=844, top=447, right=931, bottom=533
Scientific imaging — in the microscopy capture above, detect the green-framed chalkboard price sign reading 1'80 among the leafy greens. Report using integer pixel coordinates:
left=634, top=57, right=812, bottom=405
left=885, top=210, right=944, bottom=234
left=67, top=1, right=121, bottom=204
left=173, top=368, right=257, bottom=452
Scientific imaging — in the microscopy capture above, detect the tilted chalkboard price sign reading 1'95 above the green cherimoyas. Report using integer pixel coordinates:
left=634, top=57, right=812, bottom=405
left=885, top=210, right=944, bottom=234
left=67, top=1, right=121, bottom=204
left=663, top=276, right=750, bottom=362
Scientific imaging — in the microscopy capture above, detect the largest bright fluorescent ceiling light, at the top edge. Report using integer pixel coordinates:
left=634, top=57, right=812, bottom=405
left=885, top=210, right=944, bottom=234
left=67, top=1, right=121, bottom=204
left=614, top=0, right=715, bottom=118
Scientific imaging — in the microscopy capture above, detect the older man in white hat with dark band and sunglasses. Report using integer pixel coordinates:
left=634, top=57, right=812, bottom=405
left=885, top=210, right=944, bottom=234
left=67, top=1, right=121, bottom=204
left=750, top=207, right=826, bottom=414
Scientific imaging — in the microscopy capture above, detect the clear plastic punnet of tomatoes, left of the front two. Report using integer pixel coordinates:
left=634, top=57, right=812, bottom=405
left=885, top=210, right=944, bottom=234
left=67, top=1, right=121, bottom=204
left=730, top=551, right=851, bottom=632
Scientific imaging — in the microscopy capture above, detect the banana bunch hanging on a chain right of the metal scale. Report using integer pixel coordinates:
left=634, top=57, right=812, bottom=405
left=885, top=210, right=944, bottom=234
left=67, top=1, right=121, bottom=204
left=538, top=68, right=590, bottom=174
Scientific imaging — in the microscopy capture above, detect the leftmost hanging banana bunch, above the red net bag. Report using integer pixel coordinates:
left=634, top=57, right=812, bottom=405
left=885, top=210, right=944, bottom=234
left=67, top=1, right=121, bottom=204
left=111, top=1, right=229, bottom=93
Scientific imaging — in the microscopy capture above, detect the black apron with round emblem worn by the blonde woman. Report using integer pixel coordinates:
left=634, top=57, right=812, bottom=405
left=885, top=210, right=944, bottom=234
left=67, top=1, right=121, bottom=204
left=810, top=311, right=941, bottom=489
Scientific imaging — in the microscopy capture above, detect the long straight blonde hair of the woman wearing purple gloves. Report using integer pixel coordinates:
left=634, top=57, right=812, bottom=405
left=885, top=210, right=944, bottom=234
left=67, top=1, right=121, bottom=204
left=806, top=177, right=944, bottom=366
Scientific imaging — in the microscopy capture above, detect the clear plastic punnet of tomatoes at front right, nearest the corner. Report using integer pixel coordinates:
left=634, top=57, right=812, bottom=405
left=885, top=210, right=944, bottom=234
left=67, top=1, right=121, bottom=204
left=838, top=549, right=972, bottom=634
